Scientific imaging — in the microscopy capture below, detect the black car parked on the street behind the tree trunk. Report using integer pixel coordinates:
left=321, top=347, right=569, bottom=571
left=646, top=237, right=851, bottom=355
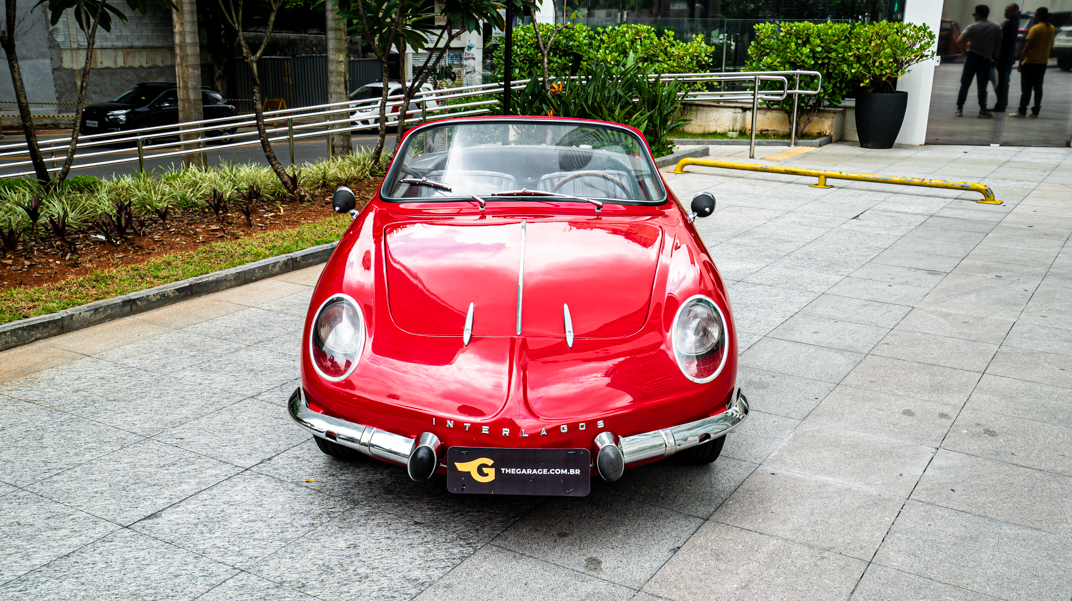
left=78, top=84, right=236, bottom=137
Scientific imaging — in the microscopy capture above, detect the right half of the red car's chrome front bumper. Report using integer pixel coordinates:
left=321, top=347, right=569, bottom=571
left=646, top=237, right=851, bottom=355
left=619, top=388, right=748, bottom=465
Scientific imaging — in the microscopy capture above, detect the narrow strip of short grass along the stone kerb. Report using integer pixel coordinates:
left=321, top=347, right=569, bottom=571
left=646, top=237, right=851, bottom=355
left=0, top=215, right=351, bottom=324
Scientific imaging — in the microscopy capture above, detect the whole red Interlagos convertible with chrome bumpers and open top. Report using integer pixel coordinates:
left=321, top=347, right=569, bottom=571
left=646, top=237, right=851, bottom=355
left=288, top=118, right=748, bottom=496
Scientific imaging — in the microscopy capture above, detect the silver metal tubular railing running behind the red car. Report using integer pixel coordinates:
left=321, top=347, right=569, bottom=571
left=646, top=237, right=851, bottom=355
left=0, top=71, right=822, bottom=178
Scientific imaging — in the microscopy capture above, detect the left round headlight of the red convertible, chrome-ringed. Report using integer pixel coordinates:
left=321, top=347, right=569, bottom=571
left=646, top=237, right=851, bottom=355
left=309, top=295, right=364, bottom=381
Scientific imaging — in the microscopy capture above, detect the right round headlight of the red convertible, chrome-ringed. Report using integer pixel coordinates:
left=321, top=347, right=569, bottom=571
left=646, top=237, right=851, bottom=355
left=671, top=295, right=726, bottom=384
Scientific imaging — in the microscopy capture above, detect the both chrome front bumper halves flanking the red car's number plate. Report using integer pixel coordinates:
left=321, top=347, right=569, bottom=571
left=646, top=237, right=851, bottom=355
left=287, top=387, right=748, bottom=480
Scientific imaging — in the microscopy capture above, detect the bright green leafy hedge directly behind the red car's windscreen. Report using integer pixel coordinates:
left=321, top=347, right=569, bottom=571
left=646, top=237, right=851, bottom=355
left=492, top=24, right=716, bottom=79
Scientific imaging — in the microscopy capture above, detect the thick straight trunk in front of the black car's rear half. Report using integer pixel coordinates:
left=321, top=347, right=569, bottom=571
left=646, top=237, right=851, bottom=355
left=172, top=0, right=206, bottom=167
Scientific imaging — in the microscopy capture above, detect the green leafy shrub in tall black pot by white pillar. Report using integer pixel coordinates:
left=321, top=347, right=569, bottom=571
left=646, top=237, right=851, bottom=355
left=852, top=21, right=935, bottom=148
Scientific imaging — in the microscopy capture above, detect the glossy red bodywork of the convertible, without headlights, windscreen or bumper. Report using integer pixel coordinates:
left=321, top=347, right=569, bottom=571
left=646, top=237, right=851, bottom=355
left=301, top=120, right=738, bottom=472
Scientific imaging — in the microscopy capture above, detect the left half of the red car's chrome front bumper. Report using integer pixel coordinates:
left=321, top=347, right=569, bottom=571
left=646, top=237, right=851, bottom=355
left=287, top=387, right=413, bottom=465
